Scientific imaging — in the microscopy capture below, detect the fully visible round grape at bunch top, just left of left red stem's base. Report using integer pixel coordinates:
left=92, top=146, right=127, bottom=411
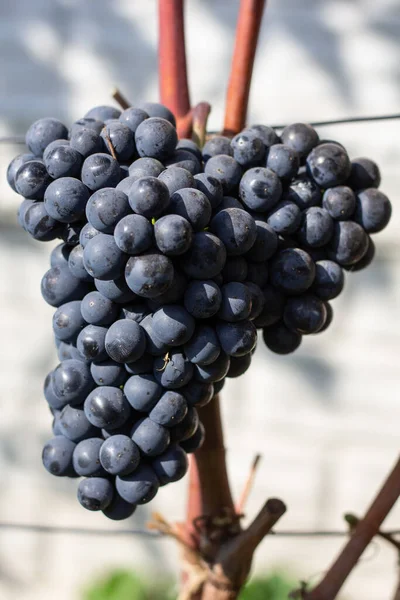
left=135, top=118, right=178, bottom=160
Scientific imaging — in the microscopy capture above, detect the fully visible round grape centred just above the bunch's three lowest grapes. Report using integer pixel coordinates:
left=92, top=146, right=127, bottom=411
left=100, top=435, right=140, bottom=475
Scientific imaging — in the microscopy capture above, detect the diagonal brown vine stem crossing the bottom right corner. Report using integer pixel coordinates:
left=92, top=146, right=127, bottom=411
left=303, top=458, right=400, bottom=600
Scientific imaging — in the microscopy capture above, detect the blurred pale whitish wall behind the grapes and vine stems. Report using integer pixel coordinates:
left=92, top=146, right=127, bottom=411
left=0, top=0, right=400, bottom=600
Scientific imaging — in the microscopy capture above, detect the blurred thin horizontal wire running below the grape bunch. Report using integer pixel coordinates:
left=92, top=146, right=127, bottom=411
left=0, top=522, right=400, bottom=538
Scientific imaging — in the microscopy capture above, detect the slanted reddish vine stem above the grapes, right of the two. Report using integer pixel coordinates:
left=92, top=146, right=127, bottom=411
left=224, top=0, right=266, bottom=135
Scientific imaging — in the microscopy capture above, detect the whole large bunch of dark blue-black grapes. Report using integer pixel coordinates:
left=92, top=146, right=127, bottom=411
left=7, top=103, right=391, bottom=520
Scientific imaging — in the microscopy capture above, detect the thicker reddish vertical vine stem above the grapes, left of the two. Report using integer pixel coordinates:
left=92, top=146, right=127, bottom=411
left=158, top=0, right=191, bottom=137
